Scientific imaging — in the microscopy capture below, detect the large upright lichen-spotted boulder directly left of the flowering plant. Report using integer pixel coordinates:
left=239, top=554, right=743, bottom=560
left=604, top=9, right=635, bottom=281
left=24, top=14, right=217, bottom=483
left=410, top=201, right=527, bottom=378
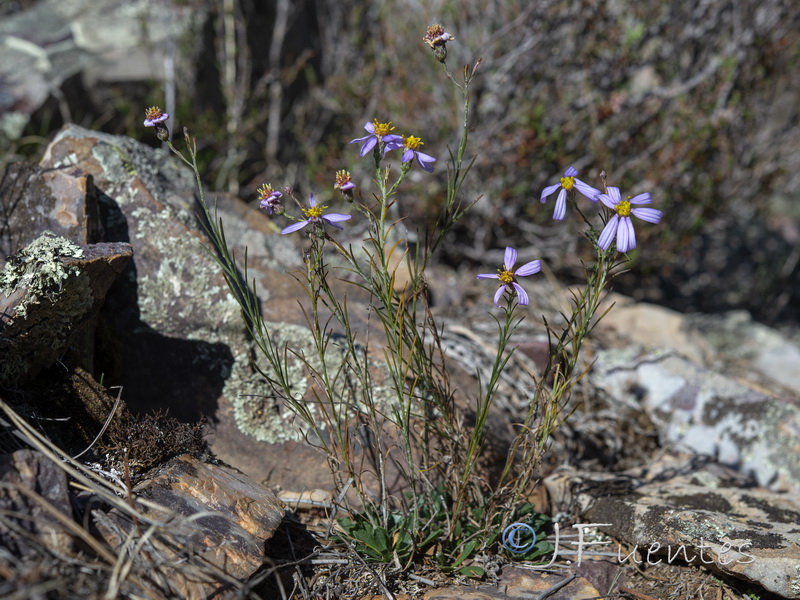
left=33, top=125, right=388, bottom=490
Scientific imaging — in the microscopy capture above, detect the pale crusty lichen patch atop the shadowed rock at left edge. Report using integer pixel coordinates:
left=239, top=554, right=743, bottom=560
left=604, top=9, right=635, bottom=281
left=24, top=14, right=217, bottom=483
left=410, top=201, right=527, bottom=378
left=0, top=231, right=83, bottom=319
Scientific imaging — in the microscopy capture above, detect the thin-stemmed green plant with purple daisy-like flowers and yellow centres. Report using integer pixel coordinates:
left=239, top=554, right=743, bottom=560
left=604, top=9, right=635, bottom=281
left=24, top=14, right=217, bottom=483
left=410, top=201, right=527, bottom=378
left=146, top=25, right=661, bottom=576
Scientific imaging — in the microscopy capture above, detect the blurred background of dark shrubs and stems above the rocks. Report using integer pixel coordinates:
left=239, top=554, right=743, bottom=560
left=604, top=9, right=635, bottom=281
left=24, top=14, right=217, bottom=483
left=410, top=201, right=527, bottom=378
left=0, top=0, right=800, bottom=326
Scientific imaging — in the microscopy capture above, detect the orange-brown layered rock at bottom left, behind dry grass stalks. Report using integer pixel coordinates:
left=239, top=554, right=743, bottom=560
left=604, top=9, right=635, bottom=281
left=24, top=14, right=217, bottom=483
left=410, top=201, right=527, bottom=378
left=93, top=455, right=284, bottom=599
